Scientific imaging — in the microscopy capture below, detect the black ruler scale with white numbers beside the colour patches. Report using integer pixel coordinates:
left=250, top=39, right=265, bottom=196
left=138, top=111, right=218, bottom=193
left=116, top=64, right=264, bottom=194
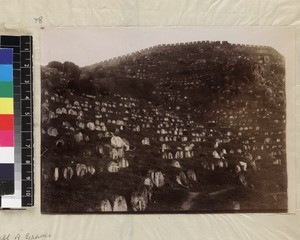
left=0, top=36, right=34, bottom=208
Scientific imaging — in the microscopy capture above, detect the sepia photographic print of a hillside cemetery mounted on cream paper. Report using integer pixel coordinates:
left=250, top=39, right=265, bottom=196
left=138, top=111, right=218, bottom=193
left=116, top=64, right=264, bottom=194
left=41, top=27, right=288, bottom=214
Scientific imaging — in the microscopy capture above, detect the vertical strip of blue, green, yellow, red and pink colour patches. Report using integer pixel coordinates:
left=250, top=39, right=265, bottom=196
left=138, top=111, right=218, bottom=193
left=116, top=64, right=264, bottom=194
left=0, top=48, right=14, bottom=206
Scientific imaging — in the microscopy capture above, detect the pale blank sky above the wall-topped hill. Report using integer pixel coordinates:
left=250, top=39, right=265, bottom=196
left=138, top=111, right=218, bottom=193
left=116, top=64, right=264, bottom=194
left=41, top=27, right=293, bottom=67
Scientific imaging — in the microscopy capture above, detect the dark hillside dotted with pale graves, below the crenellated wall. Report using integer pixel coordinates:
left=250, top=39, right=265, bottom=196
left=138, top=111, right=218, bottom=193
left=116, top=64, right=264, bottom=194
left=42, top=42, right=287, bottom=212
